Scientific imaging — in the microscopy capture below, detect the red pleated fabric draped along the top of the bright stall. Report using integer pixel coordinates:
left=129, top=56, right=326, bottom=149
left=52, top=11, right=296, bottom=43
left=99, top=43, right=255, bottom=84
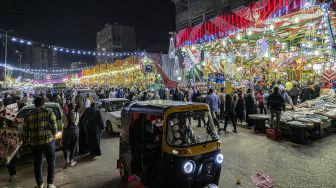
left=176, top=0, right=302, bottom=47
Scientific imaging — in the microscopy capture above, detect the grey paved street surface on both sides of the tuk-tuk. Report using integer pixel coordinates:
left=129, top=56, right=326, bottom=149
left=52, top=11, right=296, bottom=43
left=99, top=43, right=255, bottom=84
left=0, top=127, right=336, bottom=188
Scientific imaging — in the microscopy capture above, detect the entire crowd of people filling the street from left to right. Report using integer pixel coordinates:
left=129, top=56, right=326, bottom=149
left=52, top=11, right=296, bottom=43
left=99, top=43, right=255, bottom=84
left=0, top=78, right=334, bottom=188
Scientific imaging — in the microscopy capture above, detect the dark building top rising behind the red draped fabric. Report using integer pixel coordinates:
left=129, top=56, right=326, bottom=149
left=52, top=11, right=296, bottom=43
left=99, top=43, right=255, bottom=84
left=172, top=0, right=251, bottom=30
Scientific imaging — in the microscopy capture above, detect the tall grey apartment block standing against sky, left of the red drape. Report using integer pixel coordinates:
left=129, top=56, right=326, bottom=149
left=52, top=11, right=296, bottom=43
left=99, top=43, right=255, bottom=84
left=97, top=23, right=136, bottom=64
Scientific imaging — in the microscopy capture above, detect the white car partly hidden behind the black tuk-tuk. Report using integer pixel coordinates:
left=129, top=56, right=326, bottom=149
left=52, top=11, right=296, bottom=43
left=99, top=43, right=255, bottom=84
left=99, top=98, right=129, bottom=135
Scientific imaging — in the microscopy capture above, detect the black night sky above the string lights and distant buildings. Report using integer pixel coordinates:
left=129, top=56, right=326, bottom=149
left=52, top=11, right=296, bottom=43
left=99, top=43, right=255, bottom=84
left=0, top=0, right=175, bottom=67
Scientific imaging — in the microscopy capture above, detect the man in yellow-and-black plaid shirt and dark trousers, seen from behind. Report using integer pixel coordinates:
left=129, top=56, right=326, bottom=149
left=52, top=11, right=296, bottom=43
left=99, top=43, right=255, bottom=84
left=23, top=97, right=57, bottom=188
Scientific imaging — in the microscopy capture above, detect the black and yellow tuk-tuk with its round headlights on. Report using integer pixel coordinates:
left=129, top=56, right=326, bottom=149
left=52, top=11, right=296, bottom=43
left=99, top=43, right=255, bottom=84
left=117, top=100, right=224, bottom=188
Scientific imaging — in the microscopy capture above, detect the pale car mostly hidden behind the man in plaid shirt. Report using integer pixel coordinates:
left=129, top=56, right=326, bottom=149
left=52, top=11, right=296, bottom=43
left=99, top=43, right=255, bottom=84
left=14, top=103, right=63, bottom=148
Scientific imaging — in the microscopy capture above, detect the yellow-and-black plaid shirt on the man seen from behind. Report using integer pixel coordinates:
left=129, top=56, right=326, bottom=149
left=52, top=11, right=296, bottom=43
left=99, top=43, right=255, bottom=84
left=23, top=107, right=57, bottom=146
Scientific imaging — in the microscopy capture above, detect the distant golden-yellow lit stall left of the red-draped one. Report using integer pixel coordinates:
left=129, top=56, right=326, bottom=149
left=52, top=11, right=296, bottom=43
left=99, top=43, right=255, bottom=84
left=76, top=53, right=177, bottom=88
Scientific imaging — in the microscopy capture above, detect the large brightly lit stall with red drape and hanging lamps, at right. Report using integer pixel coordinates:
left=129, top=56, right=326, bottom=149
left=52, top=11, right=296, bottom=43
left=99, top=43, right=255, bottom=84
left=176, top=0, right=336, bottom=89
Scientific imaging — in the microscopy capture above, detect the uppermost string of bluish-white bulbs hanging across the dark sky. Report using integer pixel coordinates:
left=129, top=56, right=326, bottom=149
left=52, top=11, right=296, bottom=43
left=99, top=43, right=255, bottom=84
left=0, top=34, right=144, bottom=57
